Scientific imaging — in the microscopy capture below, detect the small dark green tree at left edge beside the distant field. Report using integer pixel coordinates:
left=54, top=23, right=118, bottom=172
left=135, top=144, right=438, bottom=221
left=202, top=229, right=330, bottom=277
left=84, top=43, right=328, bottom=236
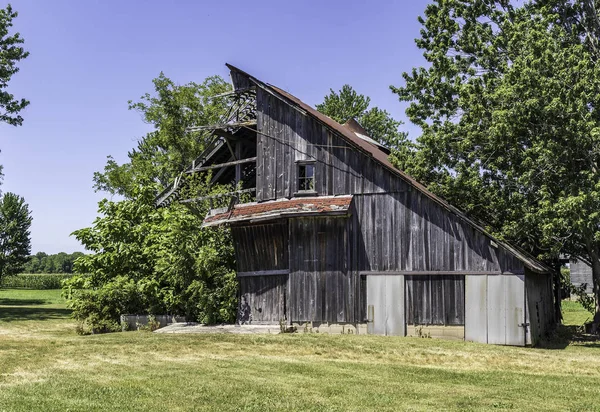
left=0, top=193, right=32, bottom=280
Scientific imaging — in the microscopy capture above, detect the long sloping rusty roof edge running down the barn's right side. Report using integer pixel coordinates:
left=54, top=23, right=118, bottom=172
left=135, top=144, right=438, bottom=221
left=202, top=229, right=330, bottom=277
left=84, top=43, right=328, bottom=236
left=226, top=64, right=552, bottom=273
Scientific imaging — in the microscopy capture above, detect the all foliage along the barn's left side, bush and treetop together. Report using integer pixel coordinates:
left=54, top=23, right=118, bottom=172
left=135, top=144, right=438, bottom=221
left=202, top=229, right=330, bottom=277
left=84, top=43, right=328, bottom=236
left=69, top=73, right=237, bottom=332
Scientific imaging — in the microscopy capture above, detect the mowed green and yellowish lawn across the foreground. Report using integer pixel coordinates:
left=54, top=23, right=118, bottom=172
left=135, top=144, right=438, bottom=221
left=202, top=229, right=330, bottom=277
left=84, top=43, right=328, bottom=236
left=0, top=290, right=600, bottom=411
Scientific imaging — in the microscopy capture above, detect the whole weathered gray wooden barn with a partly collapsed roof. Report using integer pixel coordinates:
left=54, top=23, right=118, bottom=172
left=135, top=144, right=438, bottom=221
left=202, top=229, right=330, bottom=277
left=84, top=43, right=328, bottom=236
left=157, top=65, right=554, bottom=345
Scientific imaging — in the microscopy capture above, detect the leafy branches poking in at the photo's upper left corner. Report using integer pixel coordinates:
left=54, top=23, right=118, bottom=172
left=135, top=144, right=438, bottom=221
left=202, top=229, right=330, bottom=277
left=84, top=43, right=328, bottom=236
left=0, top=4, right=29, bottom=126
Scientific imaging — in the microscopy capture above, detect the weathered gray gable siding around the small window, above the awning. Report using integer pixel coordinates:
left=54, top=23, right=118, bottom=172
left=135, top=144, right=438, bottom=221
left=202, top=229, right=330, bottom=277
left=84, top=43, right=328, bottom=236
left=256, top=90, right=408, bottom=201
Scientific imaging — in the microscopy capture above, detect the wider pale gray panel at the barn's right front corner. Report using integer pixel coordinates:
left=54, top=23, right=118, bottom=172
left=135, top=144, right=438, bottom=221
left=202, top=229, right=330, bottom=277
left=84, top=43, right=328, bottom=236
left=487, top=275, right=525, bottom=346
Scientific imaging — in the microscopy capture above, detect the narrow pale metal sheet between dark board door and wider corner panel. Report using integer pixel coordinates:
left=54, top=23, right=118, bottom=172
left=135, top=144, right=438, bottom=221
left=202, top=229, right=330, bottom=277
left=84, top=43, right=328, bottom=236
left=465, top=275, right=488, bottom=343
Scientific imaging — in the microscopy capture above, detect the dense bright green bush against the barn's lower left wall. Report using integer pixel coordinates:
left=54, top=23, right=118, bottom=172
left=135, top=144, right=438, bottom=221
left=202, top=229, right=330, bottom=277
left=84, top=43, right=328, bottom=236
left=65, top=185, right=237, bottom=331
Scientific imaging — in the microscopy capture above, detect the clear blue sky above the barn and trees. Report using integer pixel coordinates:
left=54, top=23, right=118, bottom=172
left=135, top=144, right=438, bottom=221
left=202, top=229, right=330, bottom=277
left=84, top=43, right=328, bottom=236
left=0, top=0, right=427, bottom=253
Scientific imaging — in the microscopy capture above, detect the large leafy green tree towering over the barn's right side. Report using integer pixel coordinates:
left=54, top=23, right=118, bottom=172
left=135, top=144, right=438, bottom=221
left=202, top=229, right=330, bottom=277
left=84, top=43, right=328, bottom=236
left=392, top=0, right=600, bottom=324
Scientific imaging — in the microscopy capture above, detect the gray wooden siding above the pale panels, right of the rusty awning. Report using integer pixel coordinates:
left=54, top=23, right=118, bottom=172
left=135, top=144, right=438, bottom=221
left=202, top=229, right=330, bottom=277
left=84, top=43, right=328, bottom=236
left=352, top=191, right=523, bottom=273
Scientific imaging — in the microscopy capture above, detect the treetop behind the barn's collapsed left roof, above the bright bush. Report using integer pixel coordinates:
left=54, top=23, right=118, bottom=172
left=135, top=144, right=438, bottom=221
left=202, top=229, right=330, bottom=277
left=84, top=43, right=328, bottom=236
left=94, top=73, right=231, bottom=198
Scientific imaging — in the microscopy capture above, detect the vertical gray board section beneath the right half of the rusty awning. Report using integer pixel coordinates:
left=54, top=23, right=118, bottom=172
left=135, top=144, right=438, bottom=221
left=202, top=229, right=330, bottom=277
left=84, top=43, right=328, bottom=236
left=289, top=218, right=358, bottom=323
